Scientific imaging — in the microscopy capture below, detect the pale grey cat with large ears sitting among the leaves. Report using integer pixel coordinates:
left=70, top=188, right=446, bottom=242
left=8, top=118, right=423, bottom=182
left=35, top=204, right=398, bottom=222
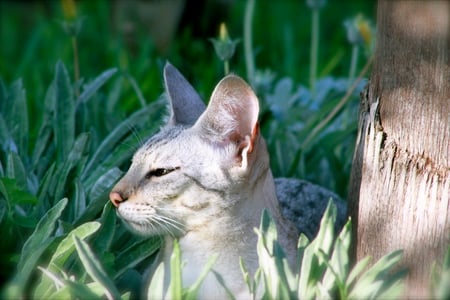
left=110, top=63, right=345, bottom=299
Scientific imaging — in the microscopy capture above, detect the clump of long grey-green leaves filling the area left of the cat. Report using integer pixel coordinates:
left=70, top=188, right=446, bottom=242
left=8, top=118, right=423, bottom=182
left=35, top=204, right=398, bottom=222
left=0, top=62, right=164, bottom=299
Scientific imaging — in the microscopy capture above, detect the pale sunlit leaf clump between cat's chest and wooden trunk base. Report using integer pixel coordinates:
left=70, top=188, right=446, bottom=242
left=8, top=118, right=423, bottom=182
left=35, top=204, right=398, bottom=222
left=250, top=201, right=406, bottom=299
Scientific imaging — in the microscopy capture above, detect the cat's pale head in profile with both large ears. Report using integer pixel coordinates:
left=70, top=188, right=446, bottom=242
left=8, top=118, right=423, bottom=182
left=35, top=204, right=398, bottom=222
left=110, top=64, right=268, bottom=236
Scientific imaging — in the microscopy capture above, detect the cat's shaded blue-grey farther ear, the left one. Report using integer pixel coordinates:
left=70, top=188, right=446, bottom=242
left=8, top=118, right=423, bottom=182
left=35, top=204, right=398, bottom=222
left=164, top=62, right=205, bottom=125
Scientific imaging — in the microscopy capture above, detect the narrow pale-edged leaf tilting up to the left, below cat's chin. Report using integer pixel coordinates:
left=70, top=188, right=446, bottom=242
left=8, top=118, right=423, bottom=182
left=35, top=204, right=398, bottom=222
left=73, top=236, right=120, bottom=299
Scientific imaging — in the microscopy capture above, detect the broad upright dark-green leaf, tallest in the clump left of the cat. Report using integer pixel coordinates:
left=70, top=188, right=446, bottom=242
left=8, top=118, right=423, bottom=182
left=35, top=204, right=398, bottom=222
left=53, top=61, right=75, bottom=162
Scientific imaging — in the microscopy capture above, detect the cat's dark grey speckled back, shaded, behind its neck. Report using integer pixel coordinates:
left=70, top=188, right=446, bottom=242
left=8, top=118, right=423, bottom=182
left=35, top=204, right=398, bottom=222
left=275, top=178, right=347, bottom=239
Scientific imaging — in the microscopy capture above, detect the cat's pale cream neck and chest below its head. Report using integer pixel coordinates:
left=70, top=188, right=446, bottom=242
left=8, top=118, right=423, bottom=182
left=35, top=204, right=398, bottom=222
left=160, top=140, right=296, bottom=298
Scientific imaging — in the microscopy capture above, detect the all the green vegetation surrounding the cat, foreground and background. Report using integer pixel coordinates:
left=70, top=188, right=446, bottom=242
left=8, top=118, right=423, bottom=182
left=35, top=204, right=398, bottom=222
left=0, top=1, right=448, bottom=299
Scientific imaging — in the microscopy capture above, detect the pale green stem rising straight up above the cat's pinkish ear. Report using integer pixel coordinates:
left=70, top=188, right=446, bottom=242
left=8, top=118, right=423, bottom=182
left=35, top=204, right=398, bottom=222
left=244, top=0, right=255, bottom=86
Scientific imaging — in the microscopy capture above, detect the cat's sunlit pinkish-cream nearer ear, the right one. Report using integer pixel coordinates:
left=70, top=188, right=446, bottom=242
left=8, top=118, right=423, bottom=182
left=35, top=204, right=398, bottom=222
left=195, top=75, right=259, bottom=163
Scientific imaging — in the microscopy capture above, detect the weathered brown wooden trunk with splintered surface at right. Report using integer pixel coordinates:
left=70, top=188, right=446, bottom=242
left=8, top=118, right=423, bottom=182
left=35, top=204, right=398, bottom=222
left=349, top=0, right=450, bottom=298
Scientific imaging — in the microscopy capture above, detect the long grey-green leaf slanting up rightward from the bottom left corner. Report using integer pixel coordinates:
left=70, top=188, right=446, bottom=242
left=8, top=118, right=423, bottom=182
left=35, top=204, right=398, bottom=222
left=7, top=199, right=68, bottom=298
